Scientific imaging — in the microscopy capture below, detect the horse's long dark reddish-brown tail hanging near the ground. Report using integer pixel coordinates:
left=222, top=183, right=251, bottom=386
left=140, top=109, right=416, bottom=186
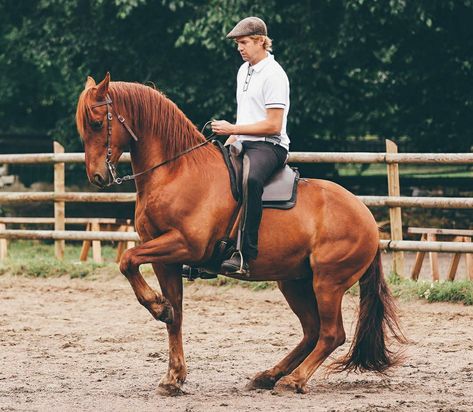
left=334, top=249, right=406, bottom=372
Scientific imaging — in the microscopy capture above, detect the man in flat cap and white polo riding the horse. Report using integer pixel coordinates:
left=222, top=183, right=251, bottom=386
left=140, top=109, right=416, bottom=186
left=212, top=17, right=289, bottom=274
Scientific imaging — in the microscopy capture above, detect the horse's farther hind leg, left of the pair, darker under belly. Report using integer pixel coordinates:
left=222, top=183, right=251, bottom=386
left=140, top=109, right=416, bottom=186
left=247, top=278, right=319, bottom=389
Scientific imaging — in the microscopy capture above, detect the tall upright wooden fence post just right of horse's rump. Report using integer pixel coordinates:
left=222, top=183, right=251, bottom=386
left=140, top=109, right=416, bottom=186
left=386, top=139, right=404, bottom=277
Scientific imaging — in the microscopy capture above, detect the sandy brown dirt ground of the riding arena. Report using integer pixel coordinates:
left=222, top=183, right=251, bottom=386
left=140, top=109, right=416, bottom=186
left=0, top=253, right=473, bottom=412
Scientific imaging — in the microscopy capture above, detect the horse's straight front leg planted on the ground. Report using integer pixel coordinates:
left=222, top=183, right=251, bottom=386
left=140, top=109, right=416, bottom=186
left=153, top=264, right=187, bottom=395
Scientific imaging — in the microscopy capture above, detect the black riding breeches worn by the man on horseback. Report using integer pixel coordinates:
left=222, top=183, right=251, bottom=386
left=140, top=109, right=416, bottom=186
left=241, top=142, right=287, bottom=259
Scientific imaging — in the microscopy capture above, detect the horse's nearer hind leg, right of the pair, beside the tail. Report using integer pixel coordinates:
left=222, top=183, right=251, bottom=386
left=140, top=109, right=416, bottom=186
left=276, top=268, right=350, bottom=393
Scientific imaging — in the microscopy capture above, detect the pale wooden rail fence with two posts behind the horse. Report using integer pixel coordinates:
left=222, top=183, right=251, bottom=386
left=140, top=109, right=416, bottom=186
left=0, top=140, right=473, bottom=276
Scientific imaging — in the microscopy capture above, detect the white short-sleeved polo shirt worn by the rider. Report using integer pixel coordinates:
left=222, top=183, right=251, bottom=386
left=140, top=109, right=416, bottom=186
left=236, top=53, right=289, bottom=150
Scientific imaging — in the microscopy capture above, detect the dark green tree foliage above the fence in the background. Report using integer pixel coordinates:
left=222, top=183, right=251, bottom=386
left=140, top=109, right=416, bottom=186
left=0, top=0, right=473, bottom=151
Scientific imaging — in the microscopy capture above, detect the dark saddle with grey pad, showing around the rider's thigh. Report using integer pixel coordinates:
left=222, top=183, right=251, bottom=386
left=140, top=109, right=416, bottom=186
left=213, top=140, right=299, bottom=209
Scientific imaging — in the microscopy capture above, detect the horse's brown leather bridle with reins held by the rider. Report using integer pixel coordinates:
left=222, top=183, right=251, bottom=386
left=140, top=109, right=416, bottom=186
left=91, top=94, right=215, bottom=187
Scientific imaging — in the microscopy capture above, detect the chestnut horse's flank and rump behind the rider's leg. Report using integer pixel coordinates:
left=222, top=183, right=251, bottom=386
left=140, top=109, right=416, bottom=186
left=251, top=180, right=379, bottom=280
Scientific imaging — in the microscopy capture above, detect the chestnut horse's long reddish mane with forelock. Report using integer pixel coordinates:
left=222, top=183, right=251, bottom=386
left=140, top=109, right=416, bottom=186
left=76, top=82, right=218, bottom=167
